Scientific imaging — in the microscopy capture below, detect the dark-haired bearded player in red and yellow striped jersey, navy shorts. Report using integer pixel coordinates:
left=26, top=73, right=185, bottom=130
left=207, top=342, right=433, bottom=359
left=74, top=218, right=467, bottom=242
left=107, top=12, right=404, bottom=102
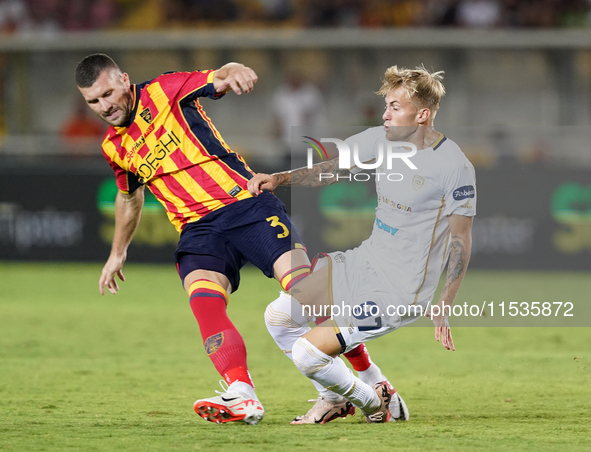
left=75, top=54, right=388, bottom=424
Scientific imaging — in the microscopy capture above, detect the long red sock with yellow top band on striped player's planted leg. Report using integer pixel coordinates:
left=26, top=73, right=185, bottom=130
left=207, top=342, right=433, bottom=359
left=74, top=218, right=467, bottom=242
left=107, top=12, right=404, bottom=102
left=189, top=279, right=254, bottom=387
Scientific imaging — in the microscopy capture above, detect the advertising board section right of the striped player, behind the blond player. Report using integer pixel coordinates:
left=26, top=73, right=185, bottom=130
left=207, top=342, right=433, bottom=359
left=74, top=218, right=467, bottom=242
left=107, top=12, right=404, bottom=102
left=290, top=166, right=591, bottom=270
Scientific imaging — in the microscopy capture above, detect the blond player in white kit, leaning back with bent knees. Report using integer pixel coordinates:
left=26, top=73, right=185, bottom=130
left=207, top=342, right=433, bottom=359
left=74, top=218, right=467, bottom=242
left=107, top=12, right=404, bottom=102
left=248, top=66, right=476, bottom=423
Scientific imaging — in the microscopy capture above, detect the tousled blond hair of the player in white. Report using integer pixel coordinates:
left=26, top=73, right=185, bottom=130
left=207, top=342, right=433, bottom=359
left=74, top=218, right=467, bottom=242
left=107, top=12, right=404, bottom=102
left=376, top=65, right=445, bottom=111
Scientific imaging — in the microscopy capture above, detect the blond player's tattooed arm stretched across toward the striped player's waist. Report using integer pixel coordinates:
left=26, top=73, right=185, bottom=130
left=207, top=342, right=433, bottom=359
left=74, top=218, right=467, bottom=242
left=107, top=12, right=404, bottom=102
left=248, top=158, right=351, bottom=196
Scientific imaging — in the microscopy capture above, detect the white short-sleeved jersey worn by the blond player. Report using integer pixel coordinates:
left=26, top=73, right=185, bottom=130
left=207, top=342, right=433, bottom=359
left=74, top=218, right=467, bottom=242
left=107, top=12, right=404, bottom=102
left=345, top=127, right=476, bottom=306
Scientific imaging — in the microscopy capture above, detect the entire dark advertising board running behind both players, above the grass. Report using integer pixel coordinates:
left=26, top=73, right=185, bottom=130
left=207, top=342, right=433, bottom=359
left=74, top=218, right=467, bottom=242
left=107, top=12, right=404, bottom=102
left=0, top=164, right=591, bottom=270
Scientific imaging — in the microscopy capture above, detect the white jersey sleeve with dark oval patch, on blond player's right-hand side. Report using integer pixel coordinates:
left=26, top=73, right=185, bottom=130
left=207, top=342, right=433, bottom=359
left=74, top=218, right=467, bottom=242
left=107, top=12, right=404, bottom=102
left=443, top=161, right=476, bottom=217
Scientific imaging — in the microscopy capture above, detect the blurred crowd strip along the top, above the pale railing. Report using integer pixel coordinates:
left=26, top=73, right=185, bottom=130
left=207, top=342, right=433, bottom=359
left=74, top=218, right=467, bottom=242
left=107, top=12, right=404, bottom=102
left=0, top=0, right=591, bottom=33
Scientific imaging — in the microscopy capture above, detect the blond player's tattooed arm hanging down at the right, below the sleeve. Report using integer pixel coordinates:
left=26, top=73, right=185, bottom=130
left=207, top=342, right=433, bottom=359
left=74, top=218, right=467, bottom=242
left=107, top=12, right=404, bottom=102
left=432, top=215, right=473, bottom=350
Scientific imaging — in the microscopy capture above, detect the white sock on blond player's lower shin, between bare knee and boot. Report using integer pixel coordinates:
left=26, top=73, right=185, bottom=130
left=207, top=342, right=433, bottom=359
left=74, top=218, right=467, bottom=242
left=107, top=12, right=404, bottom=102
left=292, top=337, right=381, bottom=413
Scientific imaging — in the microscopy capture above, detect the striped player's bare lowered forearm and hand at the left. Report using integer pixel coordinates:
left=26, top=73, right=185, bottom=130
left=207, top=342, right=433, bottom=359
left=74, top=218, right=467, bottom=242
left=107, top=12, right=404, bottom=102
left=99, top=186, right=144, bottom=295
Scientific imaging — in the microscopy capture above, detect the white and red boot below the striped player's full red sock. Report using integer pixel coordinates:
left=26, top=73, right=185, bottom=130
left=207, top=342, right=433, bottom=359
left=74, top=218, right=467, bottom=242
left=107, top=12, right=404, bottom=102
left=193, top=385, right=265, bottom=425
